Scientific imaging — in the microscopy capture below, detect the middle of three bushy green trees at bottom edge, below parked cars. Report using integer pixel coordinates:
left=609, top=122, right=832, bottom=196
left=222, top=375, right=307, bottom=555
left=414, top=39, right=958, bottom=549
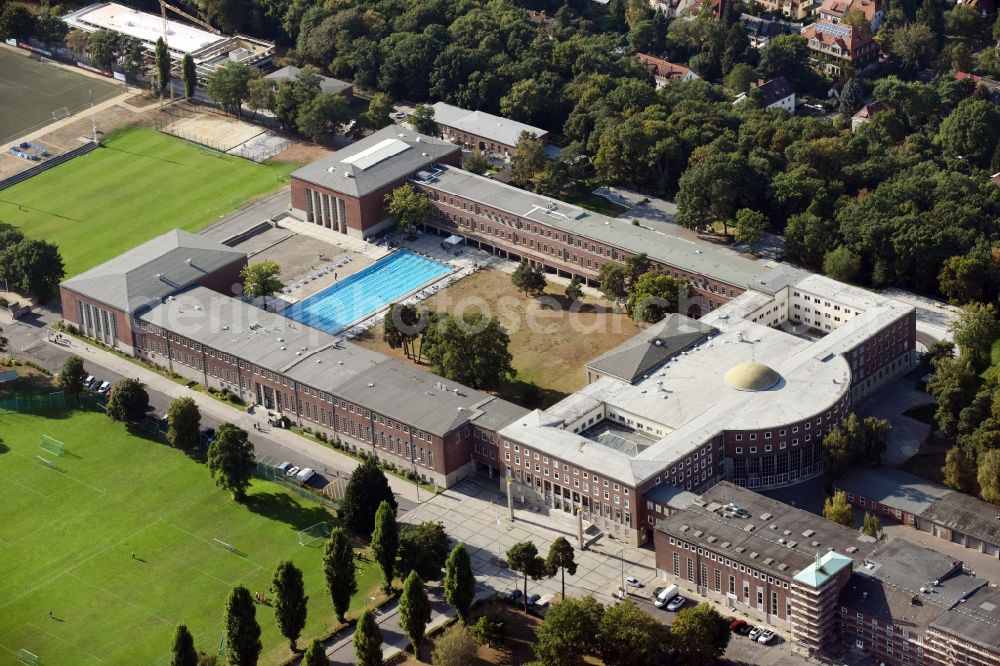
left=597, top=603, right=669, bottom=666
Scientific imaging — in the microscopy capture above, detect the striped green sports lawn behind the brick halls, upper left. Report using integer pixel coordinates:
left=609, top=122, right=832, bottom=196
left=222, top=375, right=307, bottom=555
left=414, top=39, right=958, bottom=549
left=0, top=128, right=299, bottom=277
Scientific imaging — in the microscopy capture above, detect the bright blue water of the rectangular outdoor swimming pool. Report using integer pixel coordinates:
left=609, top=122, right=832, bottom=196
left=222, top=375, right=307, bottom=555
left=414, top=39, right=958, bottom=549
left=282, top=250, right=451, bottom=333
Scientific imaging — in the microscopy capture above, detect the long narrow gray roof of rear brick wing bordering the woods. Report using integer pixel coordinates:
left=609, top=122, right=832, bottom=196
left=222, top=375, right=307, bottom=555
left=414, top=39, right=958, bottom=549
left=414, top=165, right=771, bottom=287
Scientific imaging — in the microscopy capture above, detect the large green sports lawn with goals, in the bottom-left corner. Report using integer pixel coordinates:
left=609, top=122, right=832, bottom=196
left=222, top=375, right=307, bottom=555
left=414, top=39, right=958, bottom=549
left=0, top=412, right=379, bottom=664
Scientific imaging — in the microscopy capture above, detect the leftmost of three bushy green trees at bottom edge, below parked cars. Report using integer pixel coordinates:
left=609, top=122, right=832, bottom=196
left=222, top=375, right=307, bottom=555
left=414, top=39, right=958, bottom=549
left=535, top=596, right=604, bottom=666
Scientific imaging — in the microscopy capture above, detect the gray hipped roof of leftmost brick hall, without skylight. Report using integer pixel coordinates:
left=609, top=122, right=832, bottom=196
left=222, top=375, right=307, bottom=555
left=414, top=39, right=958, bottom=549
left=62, top=229, right=246, bottom=312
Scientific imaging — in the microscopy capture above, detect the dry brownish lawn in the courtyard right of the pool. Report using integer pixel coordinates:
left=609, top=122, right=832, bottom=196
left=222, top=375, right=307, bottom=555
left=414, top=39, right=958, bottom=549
left=353, top=269, right=639, bottom=406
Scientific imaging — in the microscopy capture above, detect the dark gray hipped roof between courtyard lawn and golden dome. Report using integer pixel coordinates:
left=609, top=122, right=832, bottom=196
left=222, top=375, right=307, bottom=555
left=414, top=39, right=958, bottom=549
left=587, top=313, right=718, bottom=384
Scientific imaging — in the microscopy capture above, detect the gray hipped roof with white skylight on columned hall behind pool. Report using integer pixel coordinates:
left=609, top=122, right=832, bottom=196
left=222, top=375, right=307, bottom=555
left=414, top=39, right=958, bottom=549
left=292, top=125, right=460, bottom=197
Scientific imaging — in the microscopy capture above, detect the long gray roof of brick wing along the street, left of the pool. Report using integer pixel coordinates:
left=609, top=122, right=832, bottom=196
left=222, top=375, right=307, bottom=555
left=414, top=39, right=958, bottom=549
left=140, top=287, right=528, bottom=436
